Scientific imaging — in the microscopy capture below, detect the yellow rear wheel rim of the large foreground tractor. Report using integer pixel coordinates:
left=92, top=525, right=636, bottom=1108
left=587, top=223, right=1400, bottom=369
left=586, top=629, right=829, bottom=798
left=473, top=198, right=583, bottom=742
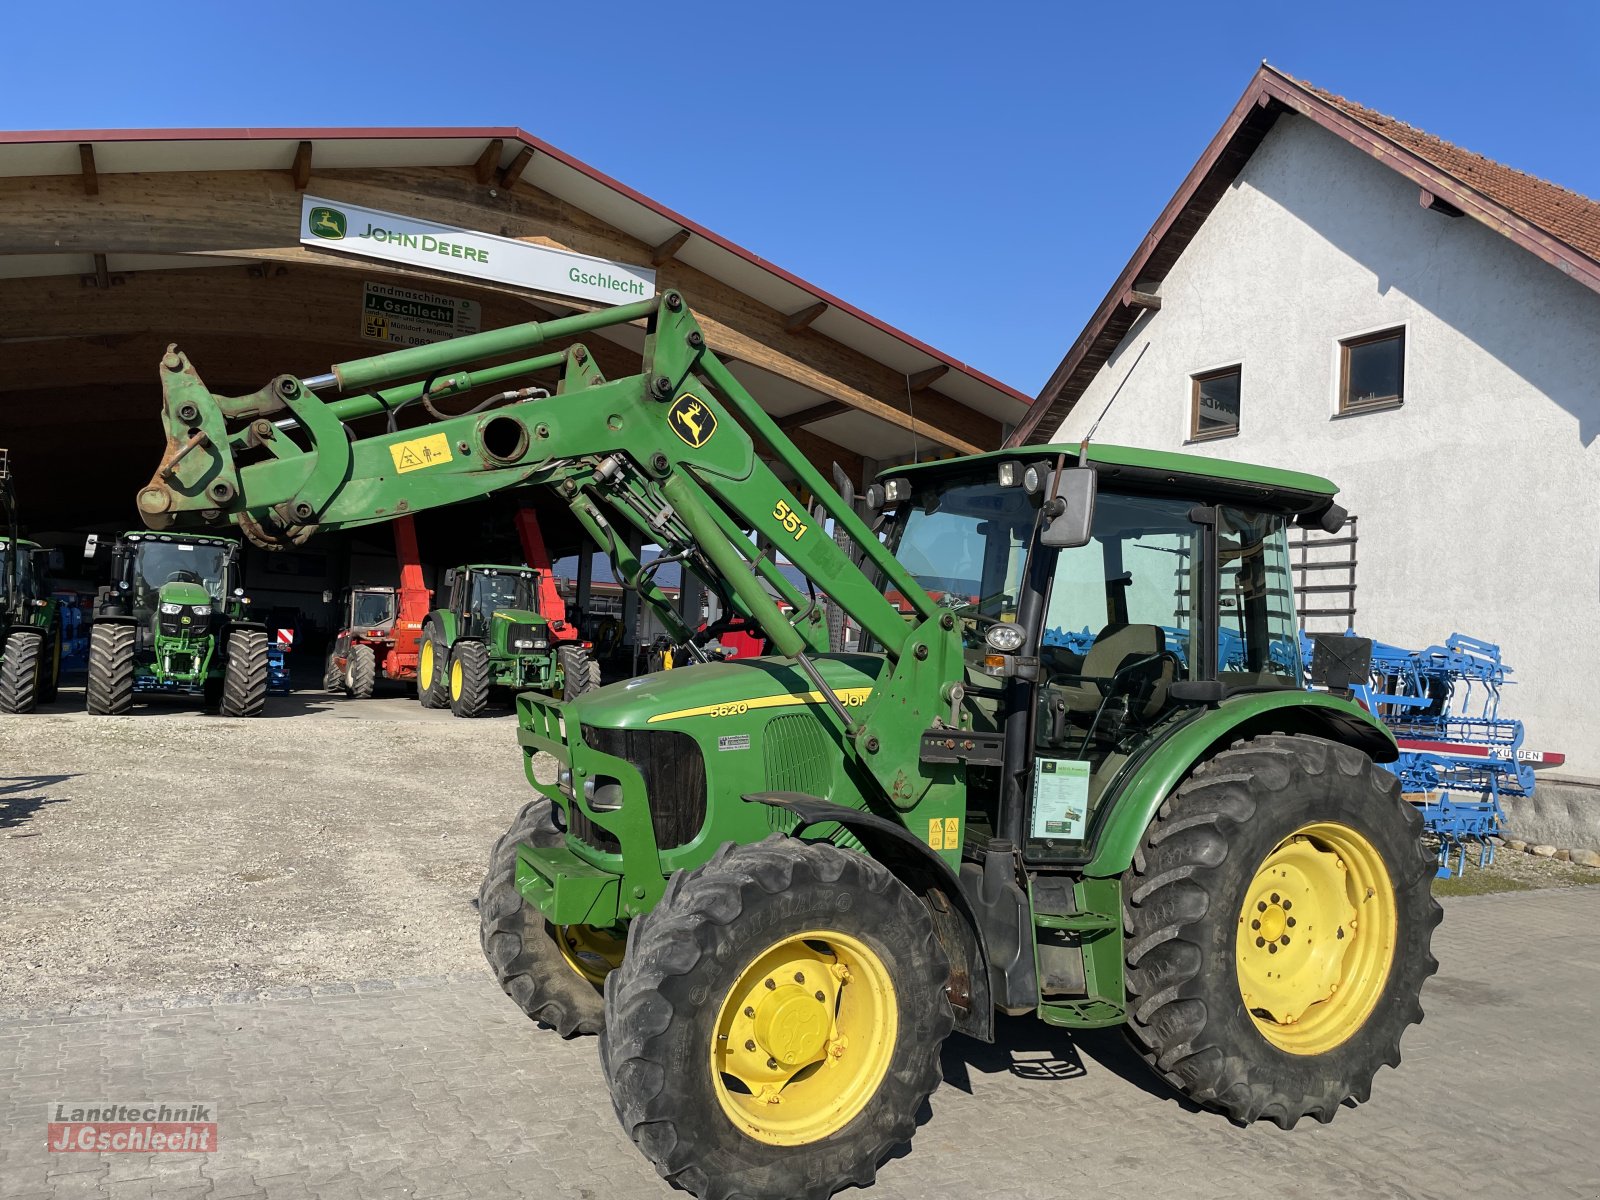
left=1234, top=821, right=1397, bottom=1054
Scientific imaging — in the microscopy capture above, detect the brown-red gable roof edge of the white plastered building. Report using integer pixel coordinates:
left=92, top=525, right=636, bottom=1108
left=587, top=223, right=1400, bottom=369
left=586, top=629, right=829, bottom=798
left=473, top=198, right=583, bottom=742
left=1006, top=62, right=1600, bottom=446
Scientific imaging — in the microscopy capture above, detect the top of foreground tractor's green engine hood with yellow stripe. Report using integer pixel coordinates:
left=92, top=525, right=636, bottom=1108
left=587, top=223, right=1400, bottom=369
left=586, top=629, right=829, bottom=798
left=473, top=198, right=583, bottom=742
left=566, top=654, right=885, bottom=730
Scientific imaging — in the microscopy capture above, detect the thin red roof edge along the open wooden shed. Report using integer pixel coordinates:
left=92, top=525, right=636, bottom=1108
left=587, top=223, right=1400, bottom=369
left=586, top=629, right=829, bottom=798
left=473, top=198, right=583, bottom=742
left=0, top=126, right=1032, bottom=405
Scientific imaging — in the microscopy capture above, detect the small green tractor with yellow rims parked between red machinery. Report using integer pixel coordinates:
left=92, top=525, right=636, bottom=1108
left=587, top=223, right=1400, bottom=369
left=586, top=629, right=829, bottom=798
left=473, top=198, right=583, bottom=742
left=416, top=563, right=600, bottom=717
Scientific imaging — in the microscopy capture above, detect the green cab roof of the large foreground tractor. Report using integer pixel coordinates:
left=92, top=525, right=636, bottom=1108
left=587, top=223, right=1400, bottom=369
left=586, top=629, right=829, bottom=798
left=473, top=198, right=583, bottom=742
left=880, top=442, right=1339, bottom=512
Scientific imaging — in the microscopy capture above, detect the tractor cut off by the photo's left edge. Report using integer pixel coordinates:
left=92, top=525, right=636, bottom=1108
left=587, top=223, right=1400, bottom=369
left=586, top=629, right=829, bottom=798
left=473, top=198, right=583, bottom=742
left=0, top=450, right=61, bottom=714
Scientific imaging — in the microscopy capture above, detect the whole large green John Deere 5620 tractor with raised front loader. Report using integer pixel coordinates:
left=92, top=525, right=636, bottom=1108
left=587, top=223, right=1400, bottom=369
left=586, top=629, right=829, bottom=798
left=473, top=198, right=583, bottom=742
left=138, top=291, right=1440, bottom=1198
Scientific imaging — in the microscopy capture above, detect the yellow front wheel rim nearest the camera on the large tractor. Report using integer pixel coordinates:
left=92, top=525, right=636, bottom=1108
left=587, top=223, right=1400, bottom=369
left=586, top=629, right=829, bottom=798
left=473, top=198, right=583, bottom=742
left=710, top=930, right=898, bottom=1146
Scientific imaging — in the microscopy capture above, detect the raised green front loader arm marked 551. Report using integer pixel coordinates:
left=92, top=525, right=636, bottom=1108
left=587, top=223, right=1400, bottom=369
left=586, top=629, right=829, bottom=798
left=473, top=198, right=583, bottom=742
left=138, top=291, right=963, bottom=808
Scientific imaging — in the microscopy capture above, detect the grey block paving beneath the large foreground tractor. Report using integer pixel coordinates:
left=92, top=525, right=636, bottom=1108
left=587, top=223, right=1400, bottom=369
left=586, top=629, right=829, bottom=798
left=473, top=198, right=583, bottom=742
left=0, top=888, right=1600, bottom=1200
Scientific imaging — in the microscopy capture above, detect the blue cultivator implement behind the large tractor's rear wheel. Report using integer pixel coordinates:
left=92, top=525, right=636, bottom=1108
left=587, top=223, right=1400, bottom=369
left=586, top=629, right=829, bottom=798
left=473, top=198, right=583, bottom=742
left=1302, top=634, right=1533, bottom=878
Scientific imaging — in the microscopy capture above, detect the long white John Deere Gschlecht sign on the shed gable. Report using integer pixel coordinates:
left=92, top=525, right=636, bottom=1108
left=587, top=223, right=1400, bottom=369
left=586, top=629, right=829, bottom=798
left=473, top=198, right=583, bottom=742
left=301, top=195, right=656, bottom=304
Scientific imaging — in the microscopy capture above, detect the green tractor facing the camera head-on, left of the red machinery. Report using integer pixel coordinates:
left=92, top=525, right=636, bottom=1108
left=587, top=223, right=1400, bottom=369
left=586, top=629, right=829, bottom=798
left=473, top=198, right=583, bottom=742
left=86, top=531, right=269, bottom=717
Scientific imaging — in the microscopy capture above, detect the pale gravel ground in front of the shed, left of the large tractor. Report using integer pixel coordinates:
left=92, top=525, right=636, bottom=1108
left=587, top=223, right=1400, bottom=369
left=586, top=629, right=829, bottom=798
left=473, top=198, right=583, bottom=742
left=0, top=691, right=533, bottom=1010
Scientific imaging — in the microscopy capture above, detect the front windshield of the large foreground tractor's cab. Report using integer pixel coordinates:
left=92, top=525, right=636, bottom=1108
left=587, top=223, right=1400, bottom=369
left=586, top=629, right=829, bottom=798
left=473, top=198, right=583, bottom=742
left=888, top=482, right=1038, bottom=645
